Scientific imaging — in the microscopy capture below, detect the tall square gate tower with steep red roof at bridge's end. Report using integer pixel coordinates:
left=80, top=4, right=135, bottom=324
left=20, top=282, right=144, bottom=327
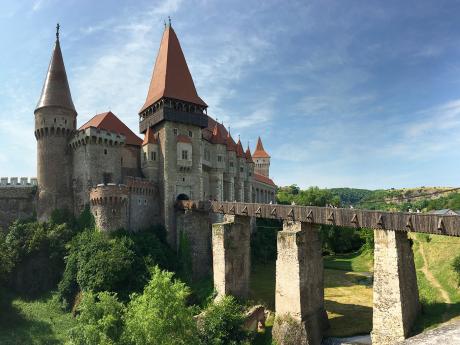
left=139, top=24, right=208, bottom=245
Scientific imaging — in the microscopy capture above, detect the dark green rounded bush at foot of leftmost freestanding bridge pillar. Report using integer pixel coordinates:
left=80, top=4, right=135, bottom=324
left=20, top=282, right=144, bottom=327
left=198, top=296, right=248, bottom=345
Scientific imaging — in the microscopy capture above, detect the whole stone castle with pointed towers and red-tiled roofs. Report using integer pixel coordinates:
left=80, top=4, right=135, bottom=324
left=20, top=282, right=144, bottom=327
left=34, top=24, right=276, bottom=243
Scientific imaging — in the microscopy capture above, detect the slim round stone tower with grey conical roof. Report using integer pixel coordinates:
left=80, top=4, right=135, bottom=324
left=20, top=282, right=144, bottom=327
left=34, top=24, right=77, bottom=220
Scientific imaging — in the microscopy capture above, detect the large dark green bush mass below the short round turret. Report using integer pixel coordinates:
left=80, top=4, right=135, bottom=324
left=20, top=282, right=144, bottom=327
left=59, top=230, right=175, bottom=307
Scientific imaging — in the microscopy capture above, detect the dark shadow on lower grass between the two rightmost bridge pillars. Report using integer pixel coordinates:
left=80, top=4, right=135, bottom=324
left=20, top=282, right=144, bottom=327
left=325, top=299, right=372, bottom=337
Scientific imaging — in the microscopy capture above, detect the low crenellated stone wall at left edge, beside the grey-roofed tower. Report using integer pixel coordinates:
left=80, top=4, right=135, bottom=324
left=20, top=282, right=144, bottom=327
left=0, top=178, right=37, bottom=230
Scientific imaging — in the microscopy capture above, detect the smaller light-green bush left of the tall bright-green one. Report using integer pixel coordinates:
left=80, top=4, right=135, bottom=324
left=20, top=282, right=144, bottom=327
left=69, top=292, right=124, bottom=345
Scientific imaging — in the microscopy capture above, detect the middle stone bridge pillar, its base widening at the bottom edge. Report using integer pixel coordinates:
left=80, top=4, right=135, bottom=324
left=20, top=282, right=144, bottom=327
left=272, top=221, right=328, bottom=345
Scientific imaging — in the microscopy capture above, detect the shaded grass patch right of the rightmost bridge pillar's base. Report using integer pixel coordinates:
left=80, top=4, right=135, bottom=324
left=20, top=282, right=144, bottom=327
left=412, top=303, right=460, bottom=335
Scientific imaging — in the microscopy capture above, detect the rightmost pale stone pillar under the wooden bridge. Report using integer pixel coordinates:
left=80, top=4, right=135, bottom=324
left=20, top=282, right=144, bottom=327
left=372, top=230, right=420, bottom=345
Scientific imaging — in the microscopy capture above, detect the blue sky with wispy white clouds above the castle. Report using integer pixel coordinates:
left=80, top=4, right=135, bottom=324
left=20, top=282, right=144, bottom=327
left=0, top=0, right=460, bottom=188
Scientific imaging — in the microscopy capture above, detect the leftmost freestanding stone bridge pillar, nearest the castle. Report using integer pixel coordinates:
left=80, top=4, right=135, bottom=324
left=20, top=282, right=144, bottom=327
left=212, top=215, right=251, bottom=298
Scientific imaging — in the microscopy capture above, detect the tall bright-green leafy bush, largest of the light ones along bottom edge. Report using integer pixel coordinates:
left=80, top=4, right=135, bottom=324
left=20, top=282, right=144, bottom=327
left=124, top=267, right=198, bottom=345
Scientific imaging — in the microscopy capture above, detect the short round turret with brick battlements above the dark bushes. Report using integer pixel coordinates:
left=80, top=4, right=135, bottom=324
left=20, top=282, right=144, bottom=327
left=89, top=183, right=129, bottom=232
